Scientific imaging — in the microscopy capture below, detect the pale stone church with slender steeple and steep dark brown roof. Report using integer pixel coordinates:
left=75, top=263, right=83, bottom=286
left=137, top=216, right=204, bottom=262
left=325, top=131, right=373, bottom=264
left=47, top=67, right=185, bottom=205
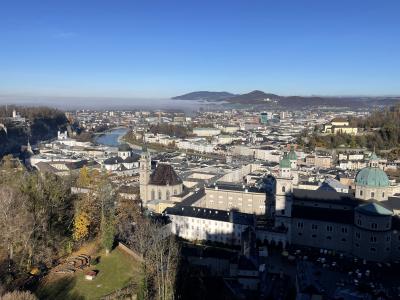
left=139, top=148, right=183, bottom=206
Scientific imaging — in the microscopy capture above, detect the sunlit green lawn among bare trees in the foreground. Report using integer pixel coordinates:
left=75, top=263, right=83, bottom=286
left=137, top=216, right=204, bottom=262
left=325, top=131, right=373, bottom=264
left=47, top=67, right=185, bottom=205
left=37, top=248, right=140, bottom=299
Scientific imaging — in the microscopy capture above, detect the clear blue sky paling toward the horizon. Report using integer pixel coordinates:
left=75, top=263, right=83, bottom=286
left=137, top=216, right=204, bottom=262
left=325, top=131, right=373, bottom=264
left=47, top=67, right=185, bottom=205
left=0, top=0, right=400, bottom=99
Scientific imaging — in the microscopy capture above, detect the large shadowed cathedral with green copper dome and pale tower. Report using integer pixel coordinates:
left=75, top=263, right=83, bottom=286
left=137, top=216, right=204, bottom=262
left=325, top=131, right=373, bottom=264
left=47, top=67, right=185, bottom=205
left=270, top=150, right=400, bottom=261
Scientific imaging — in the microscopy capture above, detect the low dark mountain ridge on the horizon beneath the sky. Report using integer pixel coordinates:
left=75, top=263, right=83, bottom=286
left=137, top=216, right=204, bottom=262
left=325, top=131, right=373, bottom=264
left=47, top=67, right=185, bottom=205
left=172, top=90, right=400, bottom=108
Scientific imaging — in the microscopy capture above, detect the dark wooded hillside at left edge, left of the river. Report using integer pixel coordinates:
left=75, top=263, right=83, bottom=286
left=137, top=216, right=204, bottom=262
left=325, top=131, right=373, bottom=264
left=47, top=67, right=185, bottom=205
left=0, top=106, right=68, bottom=157
